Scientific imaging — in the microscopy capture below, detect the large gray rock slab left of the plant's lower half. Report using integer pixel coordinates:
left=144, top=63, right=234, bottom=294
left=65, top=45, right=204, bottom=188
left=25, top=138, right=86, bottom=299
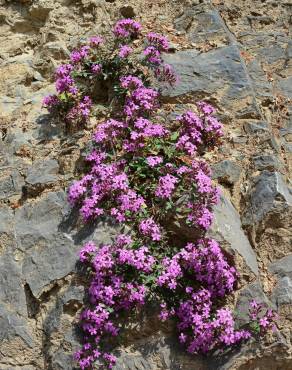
left=15, top=191, right=77, bottom=297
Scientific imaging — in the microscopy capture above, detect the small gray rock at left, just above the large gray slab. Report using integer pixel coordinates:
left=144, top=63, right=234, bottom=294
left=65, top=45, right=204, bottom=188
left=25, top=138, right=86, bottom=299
left=25, top=159, right=59, bottom=185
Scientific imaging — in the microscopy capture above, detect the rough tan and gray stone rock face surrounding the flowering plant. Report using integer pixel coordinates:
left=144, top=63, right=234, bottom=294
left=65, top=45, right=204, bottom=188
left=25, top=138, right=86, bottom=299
left=0, top=0, right=292, bottom=370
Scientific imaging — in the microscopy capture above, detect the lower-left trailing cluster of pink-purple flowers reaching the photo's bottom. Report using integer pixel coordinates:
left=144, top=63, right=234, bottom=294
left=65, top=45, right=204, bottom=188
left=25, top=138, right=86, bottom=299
left=74, top=235, right=155, bottom=369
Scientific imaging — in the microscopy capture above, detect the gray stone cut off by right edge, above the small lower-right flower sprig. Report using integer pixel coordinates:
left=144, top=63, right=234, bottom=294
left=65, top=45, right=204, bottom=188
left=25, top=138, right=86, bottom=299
left=269, top=254, right=292, bottom=306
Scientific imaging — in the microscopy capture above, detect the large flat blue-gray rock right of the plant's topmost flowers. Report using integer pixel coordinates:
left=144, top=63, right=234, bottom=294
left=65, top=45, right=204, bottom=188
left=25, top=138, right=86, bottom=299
left=163, top=45, right=260, bottom=110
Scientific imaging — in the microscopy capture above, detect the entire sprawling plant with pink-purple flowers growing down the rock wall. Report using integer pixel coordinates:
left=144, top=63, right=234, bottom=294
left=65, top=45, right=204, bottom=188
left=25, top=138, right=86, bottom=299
left=44, top=19, right=275, bottom=369
